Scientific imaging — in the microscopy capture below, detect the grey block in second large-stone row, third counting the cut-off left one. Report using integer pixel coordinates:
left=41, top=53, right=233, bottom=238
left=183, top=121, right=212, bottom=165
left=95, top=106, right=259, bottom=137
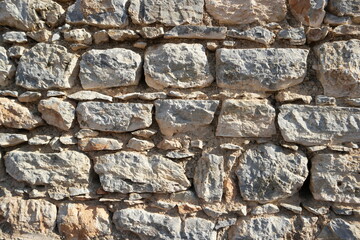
left=79, top=48, right=142, bottom=89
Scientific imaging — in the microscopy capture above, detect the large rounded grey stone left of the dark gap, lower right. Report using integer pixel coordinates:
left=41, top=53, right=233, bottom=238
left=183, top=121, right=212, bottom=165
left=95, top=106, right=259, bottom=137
left=236, top=143, right=308, bottom=203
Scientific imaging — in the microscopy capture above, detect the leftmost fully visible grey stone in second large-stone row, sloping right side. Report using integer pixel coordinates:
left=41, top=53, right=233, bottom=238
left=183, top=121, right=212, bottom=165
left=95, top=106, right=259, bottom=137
left=16, top=43, right=78, bottom=89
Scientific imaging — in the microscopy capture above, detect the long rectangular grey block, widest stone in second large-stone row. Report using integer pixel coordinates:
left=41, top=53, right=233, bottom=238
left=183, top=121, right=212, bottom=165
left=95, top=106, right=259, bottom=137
left=216, top=48, right=309, bottom=91
